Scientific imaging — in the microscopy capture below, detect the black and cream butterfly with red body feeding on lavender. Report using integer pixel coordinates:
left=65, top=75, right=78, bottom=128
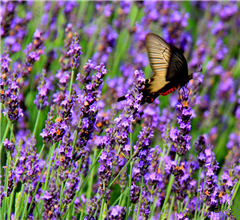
left=118, top=33, right=192, bottom=104
